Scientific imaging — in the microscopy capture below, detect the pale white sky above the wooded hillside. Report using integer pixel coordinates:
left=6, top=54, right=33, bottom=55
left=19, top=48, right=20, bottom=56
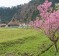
left=0, top=0, right=30, bottom=7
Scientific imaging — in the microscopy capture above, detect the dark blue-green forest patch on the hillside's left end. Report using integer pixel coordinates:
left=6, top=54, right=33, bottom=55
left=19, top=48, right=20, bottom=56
left=0, top=7, right=20, bottom=23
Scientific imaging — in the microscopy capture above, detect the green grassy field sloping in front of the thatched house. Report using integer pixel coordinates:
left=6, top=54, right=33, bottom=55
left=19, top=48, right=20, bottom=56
left=0, top=28, right=59, bottom=56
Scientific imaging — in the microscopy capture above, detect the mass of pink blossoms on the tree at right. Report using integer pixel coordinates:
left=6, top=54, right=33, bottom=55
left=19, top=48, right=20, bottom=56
left=34, top=0, right=59, bottom=35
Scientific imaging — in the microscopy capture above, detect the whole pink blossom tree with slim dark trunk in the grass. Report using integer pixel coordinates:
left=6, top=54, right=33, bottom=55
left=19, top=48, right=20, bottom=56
left=34, top=0, right=59, bottom=52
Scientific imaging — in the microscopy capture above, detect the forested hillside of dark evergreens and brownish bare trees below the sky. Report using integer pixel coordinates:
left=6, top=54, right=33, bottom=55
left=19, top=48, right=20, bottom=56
left=0, top=0, right=59, bottom=23
